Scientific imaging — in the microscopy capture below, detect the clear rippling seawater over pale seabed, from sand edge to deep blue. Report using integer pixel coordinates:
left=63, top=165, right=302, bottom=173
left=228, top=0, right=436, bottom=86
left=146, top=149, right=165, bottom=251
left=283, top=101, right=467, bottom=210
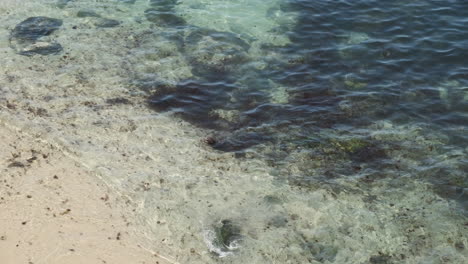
left=0, top=0, right=468, bottom=263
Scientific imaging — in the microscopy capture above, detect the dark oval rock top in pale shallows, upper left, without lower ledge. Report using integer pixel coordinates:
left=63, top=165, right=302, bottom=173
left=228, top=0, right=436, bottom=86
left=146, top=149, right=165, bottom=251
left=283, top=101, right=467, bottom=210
left=10, top=16, right=62, bottom=42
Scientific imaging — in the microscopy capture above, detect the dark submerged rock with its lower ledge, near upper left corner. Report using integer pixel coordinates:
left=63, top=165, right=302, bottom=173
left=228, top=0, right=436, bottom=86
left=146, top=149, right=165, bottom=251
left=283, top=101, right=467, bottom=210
left=10, top=16, right=62, bottom=56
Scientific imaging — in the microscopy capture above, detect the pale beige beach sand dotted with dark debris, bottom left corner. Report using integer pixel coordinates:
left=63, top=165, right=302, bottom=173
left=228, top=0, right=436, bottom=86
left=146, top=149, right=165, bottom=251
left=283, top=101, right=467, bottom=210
left=0, top=123, right=173, bottom=264
